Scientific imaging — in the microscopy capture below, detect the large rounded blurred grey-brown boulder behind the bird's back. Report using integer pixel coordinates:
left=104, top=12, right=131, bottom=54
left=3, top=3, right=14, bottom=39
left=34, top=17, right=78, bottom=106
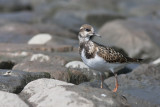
left=95, top=19, right=160, bottom=59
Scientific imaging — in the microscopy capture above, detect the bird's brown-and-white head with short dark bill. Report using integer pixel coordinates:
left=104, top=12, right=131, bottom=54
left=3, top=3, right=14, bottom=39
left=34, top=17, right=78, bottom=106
left=78, top=24, right=100, bottom=41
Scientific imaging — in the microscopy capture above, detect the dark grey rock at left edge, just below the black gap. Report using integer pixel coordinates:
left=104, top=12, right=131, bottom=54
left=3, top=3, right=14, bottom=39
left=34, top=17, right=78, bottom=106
left=0, top=70, right=50, bottom=93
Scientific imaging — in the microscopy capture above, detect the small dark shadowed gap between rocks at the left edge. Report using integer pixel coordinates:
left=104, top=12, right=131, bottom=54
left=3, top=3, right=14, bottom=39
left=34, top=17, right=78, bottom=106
left=0, top=61, right=15, bottom=69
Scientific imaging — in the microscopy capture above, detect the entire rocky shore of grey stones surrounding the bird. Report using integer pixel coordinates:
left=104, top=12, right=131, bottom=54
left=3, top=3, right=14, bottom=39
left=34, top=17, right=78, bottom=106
left=0, top=0, right=160, bottom=107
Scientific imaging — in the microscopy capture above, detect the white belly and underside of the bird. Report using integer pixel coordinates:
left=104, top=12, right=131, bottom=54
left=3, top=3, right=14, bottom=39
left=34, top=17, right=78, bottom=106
left=81, top=49, right=124, bottom=72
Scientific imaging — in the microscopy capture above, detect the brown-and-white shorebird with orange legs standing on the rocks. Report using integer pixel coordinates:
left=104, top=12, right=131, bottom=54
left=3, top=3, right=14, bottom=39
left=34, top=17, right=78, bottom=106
left=78, top=24, right=142, bottom=92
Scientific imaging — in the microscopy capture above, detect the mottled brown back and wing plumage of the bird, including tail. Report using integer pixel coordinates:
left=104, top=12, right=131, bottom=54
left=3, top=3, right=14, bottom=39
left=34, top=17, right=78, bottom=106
left=79, top=41, right=141, bottom=63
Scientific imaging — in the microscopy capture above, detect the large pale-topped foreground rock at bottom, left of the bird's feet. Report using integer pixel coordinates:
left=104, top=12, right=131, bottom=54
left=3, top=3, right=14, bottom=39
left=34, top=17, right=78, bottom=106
left=20, top=79, right=129, bottom=107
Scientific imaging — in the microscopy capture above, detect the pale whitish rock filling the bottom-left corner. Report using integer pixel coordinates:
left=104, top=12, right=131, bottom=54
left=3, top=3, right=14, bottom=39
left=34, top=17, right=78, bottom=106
left=0, top=91, right=29, bottom=107
